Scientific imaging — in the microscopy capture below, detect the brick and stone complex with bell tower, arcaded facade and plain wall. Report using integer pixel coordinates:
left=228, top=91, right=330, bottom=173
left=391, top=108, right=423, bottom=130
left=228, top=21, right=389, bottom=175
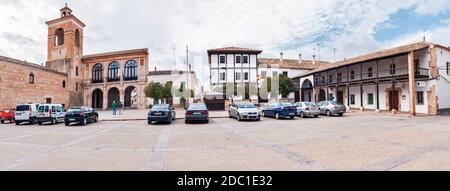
left=0, top=5, right=149, bottom=109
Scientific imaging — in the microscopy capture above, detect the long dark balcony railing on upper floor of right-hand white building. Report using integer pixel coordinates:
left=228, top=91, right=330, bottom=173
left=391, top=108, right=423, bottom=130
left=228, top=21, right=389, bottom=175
left=315, top=67, right=430, bottom=86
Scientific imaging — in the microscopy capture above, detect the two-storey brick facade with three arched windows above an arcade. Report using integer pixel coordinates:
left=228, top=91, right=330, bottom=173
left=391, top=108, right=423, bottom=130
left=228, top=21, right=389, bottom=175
left=82, top=49, right=148, bottom=109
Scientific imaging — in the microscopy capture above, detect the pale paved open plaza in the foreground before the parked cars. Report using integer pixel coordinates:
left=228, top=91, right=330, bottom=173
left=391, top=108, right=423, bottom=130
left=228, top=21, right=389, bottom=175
left=0, top=112, right=450, bottom=171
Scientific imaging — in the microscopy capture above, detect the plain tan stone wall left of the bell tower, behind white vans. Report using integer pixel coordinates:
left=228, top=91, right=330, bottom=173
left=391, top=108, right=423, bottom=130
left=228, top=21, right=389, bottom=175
left=0, top=57, right=70, bottom=109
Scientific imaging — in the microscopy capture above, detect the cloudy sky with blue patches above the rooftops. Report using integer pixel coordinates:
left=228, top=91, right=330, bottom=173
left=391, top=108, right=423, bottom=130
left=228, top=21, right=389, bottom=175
left=0, top=0, right=450, bottom=85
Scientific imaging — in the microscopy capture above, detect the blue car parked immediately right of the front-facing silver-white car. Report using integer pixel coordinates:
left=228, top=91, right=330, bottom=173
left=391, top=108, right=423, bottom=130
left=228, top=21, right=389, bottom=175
left=263, top=102, right=297, bottom=119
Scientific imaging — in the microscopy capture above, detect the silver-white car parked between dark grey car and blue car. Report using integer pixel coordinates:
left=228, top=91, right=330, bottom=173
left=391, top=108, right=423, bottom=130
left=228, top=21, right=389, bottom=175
left=228, top=102, right=261, bottom=121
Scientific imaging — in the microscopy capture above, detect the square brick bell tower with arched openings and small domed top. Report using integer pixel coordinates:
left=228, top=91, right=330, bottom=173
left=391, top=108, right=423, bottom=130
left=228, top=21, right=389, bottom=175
left=46, top=4, right=86, bottom=106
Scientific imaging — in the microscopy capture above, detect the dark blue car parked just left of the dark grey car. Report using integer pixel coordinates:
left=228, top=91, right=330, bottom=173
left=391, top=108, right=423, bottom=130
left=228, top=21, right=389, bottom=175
left=147, top=104, right=176, bottom=124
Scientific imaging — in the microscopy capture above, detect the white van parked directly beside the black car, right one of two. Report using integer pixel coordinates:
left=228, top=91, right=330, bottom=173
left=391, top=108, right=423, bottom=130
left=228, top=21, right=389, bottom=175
left=37, top=104, right=66, bottom=125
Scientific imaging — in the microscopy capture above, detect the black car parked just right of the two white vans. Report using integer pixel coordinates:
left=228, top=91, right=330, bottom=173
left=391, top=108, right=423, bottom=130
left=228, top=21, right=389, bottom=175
left=64, top=107, right=98, bottom=126
